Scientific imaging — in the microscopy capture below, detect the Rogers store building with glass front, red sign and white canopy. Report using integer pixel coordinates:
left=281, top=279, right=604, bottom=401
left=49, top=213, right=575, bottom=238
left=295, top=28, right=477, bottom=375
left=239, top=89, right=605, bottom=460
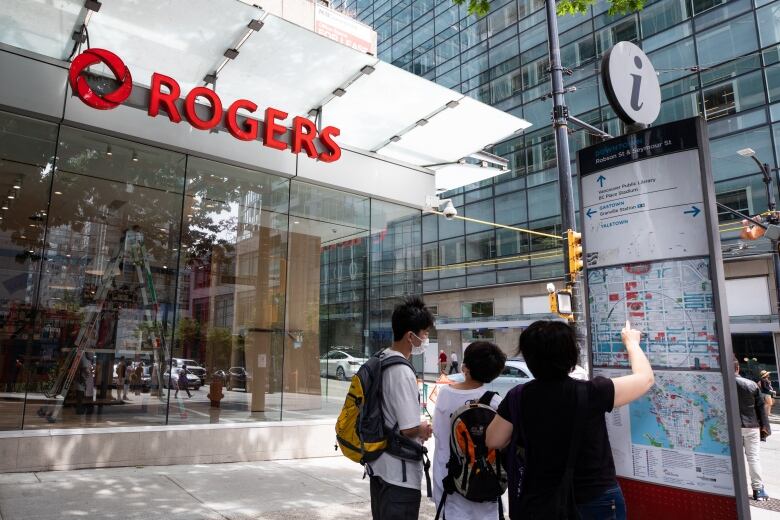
left=0, top=0, right=527, bottom=471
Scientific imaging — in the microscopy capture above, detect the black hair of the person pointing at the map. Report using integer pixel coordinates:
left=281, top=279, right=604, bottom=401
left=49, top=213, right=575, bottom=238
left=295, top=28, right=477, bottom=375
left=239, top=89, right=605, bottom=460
left=518, top=320, right=580, bottom=379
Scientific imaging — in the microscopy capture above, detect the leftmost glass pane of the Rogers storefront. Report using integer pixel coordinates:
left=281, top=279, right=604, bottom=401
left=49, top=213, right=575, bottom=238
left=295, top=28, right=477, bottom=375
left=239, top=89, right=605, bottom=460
left=0, top=112, right=57, bottom=430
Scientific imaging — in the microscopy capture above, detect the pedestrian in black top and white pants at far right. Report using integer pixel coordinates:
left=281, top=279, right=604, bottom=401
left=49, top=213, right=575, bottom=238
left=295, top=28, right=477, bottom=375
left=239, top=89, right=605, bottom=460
left=734, top=358, right=771, bottom=500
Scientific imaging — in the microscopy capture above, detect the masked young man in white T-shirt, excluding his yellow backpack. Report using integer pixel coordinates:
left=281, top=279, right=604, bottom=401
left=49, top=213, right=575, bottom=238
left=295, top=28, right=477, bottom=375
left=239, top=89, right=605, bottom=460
left=368, top=296, right=433, bottom=520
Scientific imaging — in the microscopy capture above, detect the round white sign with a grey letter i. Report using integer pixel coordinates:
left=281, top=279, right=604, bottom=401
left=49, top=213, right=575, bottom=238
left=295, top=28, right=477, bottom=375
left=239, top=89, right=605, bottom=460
left=601, top=42, right=661, bottom=125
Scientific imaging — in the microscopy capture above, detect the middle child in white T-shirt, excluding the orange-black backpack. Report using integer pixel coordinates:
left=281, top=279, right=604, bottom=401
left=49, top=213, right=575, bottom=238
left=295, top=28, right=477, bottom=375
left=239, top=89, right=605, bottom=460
left=433, top=341, right=506, bottom=520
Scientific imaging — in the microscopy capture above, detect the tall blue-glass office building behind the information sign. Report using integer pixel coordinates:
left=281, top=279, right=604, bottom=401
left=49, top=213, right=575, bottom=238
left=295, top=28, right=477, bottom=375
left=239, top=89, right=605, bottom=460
left=332, top=0, right=780, bottom=380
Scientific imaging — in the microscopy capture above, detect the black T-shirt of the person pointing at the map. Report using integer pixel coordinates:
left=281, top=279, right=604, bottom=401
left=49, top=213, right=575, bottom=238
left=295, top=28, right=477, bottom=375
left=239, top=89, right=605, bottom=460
left=498, top=377, right=616, bottom=503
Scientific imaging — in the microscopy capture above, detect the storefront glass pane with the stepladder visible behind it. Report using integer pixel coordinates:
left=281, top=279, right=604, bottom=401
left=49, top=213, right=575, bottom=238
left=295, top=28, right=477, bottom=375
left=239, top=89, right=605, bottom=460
left=32, top=126, right=185, bottom=428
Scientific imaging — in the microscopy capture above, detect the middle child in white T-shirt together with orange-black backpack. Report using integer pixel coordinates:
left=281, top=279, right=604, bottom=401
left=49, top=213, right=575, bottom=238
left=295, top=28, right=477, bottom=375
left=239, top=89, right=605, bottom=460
left=433, top=341, right=506, bottom=520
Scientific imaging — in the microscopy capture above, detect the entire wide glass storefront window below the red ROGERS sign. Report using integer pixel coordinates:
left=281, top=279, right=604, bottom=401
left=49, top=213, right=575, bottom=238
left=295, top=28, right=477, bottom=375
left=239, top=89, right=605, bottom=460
left=0, top=105, right=420, bottom=429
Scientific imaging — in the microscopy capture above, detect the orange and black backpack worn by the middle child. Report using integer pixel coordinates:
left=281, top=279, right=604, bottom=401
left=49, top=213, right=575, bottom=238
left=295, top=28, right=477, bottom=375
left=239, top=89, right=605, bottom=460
left=436, top=392, right=507, bottom=520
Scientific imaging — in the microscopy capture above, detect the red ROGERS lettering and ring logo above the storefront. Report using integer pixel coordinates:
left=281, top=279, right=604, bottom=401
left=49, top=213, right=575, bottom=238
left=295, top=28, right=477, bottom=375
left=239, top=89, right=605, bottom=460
left=68, top=49, right=341, bottom=162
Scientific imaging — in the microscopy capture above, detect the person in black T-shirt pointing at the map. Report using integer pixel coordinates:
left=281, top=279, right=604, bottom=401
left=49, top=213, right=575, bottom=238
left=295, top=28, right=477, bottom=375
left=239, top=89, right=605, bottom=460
left=487, top=320, right=655, bottom=520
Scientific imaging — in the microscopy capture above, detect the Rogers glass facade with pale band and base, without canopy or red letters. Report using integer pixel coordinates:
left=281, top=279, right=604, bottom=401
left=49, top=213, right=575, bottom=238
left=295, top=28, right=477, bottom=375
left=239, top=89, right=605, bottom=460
left=0, top=24, right=434, bottom=471
